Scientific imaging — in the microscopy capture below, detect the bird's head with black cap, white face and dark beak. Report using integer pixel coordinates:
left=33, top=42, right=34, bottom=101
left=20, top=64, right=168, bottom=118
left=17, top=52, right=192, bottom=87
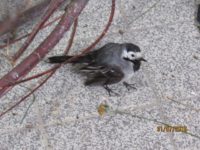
left=122, top=43, right=146, bottom=63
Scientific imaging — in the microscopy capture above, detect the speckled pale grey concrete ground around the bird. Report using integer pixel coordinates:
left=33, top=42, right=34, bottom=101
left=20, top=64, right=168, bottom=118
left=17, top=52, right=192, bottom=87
left=0, top=0, right=200, bottom=150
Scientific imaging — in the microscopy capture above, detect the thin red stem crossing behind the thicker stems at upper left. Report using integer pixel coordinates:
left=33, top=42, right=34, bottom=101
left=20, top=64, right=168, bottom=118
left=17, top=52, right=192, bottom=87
left=0, top=15, right=62, bottom=49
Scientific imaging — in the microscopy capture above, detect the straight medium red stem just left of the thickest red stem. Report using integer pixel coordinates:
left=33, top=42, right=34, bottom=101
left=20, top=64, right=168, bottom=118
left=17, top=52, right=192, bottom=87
left=13, top=0, right=65, bottom=61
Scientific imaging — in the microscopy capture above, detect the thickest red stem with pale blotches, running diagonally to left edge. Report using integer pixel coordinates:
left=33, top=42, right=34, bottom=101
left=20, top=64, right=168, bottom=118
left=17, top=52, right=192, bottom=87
left=0, top=0, right=88, bottom=97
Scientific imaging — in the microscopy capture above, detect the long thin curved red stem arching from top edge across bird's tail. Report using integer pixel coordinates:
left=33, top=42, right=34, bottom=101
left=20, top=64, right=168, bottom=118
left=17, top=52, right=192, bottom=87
left=0, top=0, right=115, bottom=86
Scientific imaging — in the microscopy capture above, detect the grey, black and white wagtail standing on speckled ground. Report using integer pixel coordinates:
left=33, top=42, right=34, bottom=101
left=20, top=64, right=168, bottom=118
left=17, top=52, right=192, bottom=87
left=47, top=43, right=146, bottom=95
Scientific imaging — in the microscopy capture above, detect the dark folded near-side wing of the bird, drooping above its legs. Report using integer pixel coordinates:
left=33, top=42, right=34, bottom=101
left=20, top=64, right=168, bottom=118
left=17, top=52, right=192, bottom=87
left=81, top=65, right=124, bottom=85
